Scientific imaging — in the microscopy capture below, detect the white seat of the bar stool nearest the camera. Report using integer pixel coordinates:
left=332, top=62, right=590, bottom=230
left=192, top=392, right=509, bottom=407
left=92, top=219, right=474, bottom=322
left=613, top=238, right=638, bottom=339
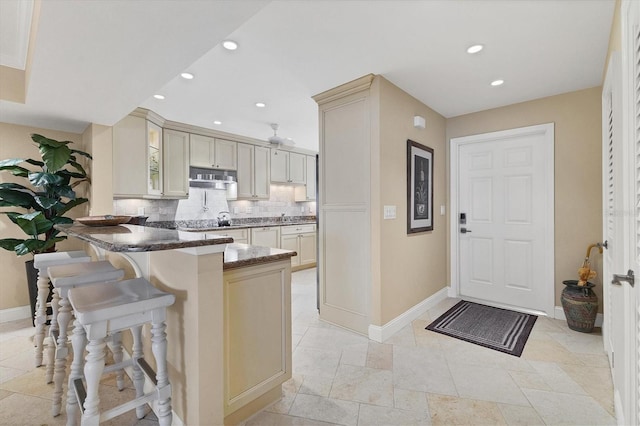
left=69, top=278, right=175, bottom=324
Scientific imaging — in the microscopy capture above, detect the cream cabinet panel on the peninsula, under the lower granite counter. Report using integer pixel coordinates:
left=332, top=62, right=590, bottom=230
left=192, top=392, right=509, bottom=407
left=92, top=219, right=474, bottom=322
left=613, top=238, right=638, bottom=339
left=223, top=260, right=292, bottom=424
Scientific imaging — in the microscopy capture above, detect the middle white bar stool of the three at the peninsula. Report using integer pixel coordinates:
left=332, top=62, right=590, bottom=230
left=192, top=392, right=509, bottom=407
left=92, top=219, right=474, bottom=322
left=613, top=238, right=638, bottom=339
left=46, top=260, right=124, bottom=417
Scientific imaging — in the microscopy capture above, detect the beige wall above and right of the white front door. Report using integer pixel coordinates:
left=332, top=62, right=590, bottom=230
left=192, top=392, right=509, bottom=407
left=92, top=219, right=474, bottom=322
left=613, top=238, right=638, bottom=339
left=447, top=87, right=602, bottom=312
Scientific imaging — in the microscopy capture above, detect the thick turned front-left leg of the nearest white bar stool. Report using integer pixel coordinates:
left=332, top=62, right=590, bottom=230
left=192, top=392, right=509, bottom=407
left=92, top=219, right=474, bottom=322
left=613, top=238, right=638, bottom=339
left=81, top=337, right=107, bottom=426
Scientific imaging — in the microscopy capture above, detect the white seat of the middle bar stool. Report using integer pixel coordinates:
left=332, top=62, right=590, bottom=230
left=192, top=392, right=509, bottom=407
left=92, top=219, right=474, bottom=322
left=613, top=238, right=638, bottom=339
left=49, top=260, right=124, bottom=289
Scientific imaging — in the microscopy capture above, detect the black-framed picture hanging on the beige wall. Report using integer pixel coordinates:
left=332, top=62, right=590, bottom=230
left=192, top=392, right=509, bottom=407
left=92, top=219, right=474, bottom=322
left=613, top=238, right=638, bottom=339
left=407, top=139, right=434, bottom=234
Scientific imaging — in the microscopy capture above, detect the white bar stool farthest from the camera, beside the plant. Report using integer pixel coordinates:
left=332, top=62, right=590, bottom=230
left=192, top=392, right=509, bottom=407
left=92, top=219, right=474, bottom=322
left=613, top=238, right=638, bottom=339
left=33, top=250, right=91, bottom=367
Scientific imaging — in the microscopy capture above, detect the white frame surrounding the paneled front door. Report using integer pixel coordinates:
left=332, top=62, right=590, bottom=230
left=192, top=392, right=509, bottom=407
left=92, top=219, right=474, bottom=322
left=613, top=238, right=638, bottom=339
left=449, top=123, right=555, bottom=317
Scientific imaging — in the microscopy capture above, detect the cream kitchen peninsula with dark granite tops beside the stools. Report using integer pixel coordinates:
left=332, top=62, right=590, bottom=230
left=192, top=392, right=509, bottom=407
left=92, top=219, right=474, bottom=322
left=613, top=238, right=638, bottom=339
left=56, top=224, right=296, bottom=425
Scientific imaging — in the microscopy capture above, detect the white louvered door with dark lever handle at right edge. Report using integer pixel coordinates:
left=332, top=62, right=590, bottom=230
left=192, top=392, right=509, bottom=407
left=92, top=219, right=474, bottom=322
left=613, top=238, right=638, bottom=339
left=602, top=1, right=640, bottom=424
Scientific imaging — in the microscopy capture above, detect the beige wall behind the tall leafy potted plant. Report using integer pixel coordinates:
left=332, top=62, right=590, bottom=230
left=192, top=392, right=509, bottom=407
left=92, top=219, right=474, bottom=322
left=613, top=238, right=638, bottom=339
left=0, top=123, right=86, bottom=310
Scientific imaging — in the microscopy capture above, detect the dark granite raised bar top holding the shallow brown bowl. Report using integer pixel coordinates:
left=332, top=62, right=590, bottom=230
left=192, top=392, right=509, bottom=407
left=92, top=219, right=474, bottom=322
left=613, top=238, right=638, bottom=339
left=55, top=224, right=233, bottom=252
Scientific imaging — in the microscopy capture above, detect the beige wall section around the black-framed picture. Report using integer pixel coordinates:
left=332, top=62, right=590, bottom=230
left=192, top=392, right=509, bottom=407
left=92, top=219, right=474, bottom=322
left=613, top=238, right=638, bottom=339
left=371, top=76, right=448, bottom=325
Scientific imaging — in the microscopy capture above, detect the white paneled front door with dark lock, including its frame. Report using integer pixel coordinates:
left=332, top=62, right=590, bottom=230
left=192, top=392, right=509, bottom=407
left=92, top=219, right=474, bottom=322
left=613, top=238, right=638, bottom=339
left=451, top=124, right=554, bottom=315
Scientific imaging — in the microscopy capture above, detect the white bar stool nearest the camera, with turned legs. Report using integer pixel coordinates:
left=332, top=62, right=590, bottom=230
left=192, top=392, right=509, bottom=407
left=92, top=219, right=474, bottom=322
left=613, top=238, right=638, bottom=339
left=67, top=278, right=175, bottom=426
